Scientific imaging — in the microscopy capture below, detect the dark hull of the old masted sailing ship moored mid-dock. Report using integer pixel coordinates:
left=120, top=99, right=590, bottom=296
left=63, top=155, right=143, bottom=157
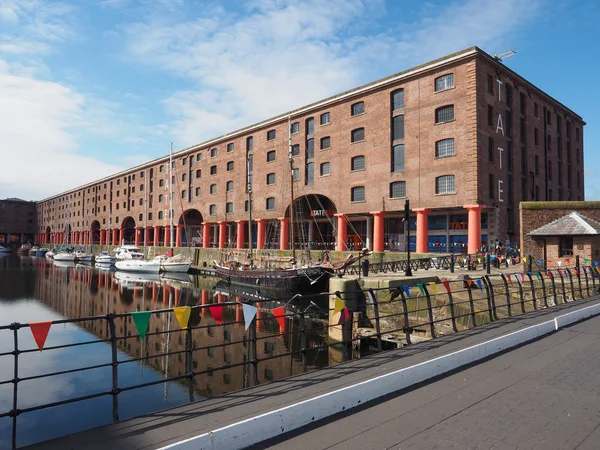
left=214, top=264, right=332, bottom=294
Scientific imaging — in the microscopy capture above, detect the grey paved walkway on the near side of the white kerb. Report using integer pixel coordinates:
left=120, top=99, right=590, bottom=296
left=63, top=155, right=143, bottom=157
left=256, top=317, right=600, bottom=450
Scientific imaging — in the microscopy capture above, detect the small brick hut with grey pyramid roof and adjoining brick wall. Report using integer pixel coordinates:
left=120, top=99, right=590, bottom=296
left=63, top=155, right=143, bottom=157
left=520, top=202, right=600, bottom=266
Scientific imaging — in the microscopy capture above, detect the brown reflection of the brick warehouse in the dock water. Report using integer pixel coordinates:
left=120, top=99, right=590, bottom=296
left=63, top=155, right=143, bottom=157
left=35, top=261, right=327, bottom=396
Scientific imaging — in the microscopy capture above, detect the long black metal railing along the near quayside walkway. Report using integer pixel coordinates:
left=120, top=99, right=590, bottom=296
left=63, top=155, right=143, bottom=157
left=0, top=266, right=600, bottom=449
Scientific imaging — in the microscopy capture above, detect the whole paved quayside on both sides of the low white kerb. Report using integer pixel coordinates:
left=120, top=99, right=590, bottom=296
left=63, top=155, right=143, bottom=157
left=32, top=297, right=600, bottom=450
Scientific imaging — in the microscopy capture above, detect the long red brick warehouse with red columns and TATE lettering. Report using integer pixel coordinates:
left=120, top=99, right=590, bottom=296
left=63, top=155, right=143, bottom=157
left=38, top=47, right=585, bottom=253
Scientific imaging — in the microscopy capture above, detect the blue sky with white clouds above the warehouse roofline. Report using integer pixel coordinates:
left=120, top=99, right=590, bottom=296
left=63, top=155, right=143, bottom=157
left=0, top=0, right=600, bottom=200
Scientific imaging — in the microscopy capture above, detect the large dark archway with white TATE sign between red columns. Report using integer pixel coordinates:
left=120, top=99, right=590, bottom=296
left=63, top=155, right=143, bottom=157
left=285, top=194, right=337, bottom=250
